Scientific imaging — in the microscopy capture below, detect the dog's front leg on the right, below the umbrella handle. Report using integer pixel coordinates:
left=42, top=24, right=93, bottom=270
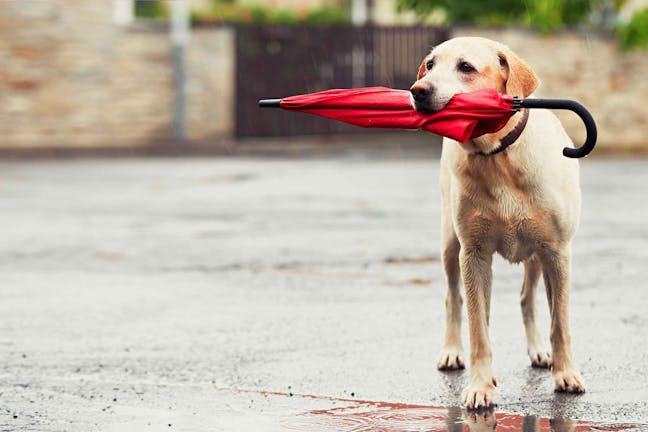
left=541, top=244, right=585, bottom=393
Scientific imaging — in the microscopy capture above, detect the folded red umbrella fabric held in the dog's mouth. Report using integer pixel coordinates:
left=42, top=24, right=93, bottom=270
left=279, top=87, right=515, bottom=142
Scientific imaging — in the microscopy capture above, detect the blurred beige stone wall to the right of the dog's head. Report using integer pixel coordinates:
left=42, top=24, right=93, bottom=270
left=453, top=28, right=648, bottom=151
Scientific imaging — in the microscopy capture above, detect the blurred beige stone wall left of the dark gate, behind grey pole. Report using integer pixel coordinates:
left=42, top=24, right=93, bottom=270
left=0, top=0, right=234, bottom=148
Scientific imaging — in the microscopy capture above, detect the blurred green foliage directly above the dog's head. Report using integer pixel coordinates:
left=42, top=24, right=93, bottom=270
left=397, top=0, right=603, bottom=32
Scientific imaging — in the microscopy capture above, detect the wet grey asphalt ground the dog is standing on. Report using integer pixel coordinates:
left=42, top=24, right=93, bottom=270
left=0, top=152, right=648, bottom=432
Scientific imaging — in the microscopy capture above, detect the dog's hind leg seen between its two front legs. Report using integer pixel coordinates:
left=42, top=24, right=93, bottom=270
left=520, top=256, right=551, bottom=368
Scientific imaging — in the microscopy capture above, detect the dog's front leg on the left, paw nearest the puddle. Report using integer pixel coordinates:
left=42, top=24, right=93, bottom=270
left=459, top=245, right=497, bottom=409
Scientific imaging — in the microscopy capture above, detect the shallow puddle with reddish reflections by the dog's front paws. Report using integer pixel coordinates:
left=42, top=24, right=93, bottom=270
left=275, top=393, right=647, bottom=432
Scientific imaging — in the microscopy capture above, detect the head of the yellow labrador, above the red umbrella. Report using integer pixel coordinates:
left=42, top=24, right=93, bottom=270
left=410, top=37, right=538, bottom=112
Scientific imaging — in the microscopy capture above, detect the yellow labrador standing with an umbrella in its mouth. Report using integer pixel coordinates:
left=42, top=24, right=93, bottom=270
left=410, top=37, right=584, bottom=409
